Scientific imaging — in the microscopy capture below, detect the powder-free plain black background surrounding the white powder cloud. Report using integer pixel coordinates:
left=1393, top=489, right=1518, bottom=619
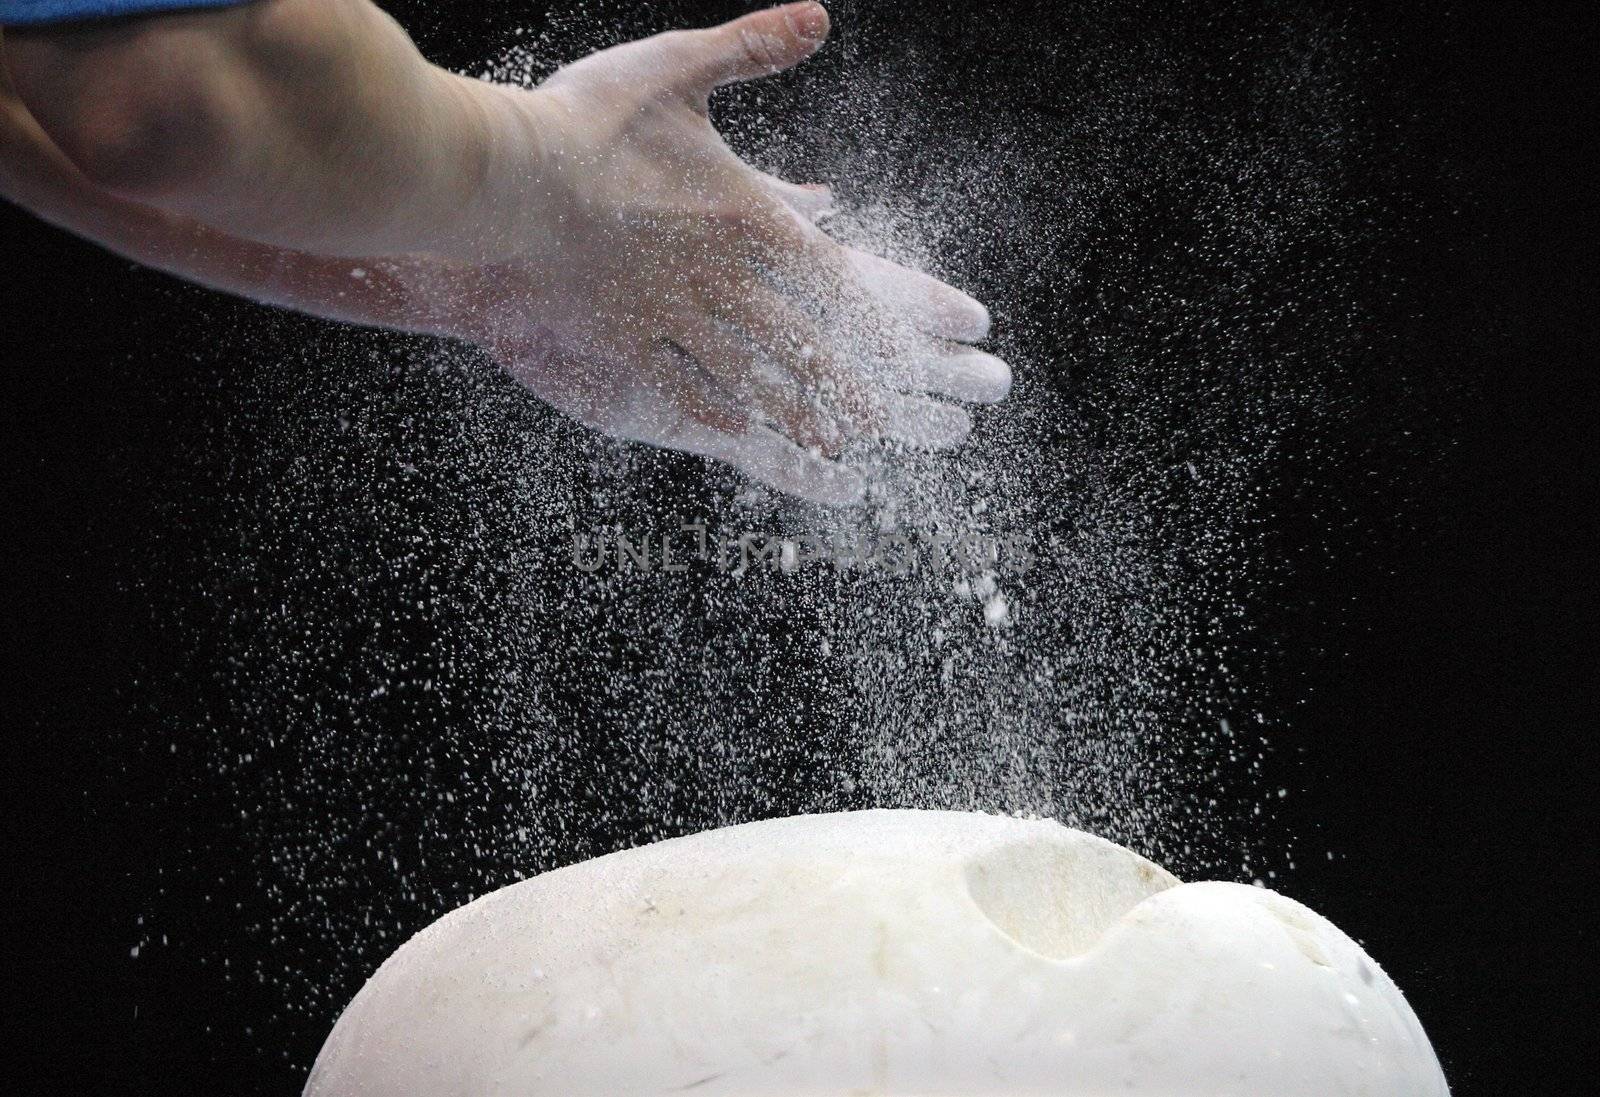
left=0, top=3, right=1600, bottom=1094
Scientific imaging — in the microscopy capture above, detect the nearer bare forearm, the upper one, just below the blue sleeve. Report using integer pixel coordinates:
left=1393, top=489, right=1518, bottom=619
left=6, top=0, right=531, bottom=257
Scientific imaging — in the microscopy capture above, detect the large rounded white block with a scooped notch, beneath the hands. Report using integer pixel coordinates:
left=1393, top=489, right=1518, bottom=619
left=306, top=811, right=1448, bottom=1097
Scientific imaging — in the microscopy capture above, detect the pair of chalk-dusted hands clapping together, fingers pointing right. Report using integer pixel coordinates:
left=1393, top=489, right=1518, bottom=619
left=422, top=3, right=1010, bottom=504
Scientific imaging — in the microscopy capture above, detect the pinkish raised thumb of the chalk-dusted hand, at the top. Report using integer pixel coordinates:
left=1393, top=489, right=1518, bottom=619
left=672, top=0, right=829, bottom=99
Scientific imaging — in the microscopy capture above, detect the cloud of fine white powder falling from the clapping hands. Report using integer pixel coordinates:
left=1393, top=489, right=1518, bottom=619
left=118, top=5, right=1459, bottom=1081
